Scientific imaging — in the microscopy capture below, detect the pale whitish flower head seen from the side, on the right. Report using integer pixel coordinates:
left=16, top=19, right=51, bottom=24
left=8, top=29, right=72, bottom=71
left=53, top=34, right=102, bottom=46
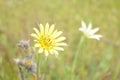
left=79, top=21, right=102, bottom=40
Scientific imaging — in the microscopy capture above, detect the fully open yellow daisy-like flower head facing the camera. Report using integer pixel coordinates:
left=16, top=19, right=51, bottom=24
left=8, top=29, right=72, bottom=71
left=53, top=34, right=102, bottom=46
left=31, top=23, right=67, bottom=56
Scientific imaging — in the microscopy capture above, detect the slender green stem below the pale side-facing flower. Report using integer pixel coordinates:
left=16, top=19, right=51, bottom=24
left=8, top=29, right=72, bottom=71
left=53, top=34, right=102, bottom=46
left=72, top=36, right=84, bottom=80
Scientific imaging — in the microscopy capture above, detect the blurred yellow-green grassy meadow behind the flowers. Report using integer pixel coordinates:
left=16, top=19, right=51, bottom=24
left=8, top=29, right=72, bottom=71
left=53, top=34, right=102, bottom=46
left=0, top=0, right=120, bottom=80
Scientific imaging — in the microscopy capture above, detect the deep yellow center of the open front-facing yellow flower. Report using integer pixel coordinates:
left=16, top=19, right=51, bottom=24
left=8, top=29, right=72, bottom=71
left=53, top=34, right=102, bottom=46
left=39, top=35, right=55, bottom=50
